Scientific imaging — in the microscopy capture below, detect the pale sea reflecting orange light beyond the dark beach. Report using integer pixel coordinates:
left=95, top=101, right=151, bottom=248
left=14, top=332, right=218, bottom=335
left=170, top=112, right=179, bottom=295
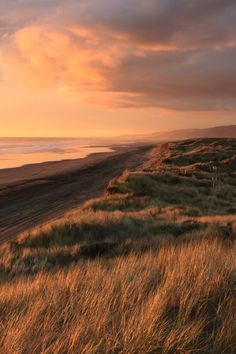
left=0, top=138, right=112, bottom=169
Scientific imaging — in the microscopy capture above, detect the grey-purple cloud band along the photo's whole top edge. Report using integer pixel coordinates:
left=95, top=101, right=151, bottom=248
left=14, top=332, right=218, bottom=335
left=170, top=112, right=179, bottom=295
left=0, top=0, right=236, bottom=47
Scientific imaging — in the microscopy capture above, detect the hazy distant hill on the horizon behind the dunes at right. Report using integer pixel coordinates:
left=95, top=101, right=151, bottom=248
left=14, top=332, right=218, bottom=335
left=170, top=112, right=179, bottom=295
left=151, top=125, right=236, bottom=140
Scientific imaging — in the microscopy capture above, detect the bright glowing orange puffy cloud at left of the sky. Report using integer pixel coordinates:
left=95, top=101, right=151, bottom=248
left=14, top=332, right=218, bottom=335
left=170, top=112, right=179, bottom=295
left=4, top=26, right=123, bottom=91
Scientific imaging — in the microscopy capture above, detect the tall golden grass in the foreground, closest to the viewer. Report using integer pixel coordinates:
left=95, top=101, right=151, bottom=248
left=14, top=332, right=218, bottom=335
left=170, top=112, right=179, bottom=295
left=0, top=240, right=236, bottom=354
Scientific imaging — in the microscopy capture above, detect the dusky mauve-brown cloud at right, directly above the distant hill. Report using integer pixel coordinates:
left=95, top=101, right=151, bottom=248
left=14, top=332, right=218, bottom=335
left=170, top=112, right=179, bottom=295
left=102, top=48, right=236, bottom=110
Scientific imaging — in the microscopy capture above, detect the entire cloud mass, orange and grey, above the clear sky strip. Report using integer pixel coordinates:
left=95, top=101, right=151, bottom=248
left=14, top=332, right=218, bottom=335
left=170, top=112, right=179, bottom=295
left=0, top=0, right=236, bottom=110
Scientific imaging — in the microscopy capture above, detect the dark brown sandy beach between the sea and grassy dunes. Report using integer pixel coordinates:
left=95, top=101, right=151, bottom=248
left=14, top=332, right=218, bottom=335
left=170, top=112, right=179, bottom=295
left=0, top=145, right=153, bottom=243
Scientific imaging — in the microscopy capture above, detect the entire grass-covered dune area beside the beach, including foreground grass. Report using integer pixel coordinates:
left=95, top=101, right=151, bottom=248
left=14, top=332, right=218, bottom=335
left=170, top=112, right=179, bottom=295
left=0, top=139, right=236, bottom=354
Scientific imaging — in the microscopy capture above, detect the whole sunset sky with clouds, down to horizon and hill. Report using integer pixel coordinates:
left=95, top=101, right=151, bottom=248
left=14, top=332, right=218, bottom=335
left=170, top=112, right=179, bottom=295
left=0, top=0, right=236, bottom=137
